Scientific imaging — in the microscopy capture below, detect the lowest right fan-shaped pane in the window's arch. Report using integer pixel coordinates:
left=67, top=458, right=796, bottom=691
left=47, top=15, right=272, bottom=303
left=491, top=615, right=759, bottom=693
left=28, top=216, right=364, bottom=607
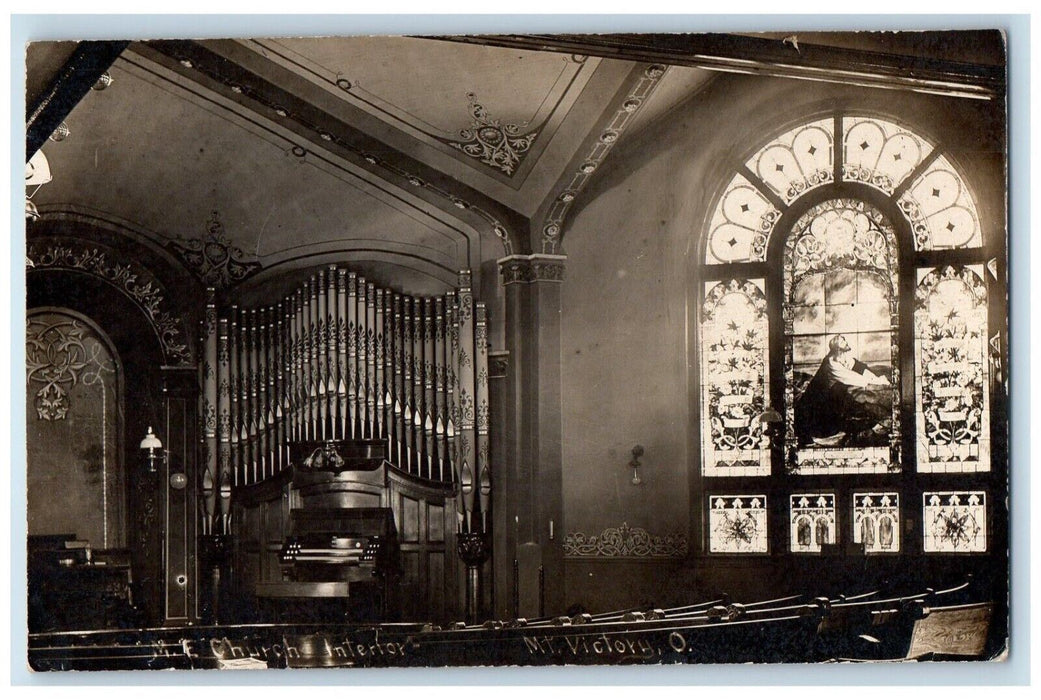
left=899, top=155, right=983, bottom=250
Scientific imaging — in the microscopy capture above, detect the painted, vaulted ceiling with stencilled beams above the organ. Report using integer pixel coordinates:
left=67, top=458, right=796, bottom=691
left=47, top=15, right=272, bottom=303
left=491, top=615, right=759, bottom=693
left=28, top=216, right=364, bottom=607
left=27, top=38, right=709, bottom=294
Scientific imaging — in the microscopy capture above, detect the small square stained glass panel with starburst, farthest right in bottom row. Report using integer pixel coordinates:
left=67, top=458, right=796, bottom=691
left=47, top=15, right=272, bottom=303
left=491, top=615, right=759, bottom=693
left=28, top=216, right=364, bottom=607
left=922, top=491, right=987, bottom=553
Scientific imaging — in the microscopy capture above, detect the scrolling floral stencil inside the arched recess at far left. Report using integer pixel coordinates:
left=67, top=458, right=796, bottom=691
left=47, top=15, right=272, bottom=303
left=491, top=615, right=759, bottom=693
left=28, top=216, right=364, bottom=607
left=25, top=316, right=116, bottom=421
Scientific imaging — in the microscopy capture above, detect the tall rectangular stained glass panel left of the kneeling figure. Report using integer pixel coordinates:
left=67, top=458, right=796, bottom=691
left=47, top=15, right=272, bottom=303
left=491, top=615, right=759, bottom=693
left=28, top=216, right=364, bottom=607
left=701, top=279, right=770, bottom=476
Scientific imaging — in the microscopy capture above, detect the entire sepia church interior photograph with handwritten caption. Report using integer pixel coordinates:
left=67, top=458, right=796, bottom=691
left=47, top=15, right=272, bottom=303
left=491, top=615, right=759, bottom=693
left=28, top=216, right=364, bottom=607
left=22, top=29, right=1010, bottom=671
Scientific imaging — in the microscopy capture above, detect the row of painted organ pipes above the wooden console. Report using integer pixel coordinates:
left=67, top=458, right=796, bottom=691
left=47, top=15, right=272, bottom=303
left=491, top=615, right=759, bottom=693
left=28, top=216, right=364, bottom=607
left=200, top=266, right=491, bottom=535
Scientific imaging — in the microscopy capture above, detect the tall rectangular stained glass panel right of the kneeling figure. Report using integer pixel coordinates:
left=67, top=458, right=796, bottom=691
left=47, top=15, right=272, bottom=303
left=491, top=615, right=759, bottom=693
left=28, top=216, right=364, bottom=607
left=914, top=265, right=990, bottom=472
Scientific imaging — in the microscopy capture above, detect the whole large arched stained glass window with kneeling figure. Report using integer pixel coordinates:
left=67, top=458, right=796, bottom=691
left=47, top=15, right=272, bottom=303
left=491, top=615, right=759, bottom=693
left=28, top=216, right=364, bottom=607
left=696, top=111, right=998, bottom=554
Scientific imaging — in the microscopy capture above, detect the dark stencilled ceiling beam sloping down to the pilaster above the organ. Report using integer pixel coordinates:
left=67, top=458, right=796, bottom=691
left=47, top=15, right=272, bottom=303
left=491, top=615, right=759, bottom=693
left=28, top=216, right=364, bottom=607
left=134, top=41, right=524, bottom=255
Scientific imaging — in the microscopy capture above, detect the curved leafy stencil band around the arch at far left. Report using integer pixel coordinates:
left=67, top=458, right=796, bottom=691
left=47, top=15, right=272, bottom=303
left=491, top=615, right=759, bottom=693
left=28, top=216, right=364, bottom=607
left=25, top=238, right=192, bottom=367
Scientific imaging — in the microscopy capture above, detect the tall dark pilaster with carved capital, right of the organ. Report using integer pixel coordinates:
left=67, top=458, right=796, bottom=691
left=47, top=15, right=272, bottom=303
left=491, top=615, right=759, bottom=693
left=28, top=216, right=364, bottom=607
left=492, top=254, right=567, bottom=618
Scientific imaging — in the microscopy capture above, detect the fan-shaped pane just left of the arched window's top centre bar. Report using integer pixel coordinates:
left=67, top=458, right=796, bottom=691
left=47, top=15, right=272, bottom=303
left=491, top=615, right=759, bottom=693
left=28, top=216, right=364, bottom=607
left=745, top=119, right=835, bottom=204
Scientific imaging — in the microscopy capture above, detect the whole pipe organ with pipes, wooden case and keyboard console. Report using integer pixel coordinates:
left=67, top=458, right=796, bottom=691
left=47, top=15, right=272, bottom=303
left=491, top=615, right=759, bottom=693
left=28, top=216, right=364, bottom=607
left=200, top=267, right=491, bottom=622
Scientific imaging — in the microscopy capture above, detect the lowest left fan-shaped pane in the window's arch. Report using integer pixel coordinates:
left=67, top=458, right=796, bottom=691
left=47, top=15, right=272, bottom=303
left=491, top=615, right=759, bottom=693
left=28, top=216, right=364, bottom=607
left=705, top=175, right=781, bottom=265
